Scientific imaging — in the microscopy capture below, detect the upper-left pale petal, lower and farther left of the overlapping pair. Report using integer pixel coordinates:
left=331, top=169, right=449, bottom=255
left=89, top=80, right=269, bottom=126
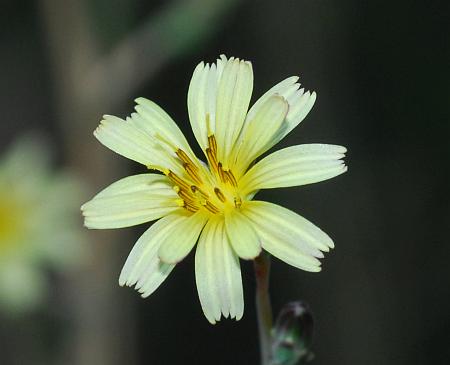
left=94, top=115, right=179, bottom=170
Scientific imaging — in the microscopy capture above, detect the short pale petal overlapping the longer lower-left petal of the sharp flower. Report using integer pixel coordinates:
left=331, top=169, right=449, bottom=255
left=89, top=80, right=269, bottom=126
left=158, top=211, right=208, bottom=264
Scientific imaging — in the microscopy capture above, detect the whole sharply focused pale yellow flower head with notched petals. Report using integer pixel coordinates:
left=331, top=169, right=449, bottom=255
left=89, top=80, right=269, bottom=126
left=82, top=56, right=346, bottom=323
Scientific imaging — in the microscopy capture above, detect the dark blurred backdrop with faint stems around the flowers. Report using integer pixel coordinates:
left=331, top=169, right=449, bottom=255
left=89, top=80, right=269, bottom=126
left=0, top=0, right=450, bottom=365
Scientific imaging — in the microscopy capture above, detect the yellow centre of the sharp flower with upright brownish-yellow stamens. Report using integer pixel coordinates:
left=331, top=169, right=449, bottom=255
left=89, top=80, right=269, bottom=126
left=164, top=135, right=242, bottom=214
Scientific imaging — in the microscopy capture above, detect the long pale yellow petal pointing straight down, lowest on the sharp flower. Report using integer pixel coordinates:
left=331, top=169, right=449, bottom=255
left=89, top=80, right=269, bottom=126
left=195, top=219, right=244, bottom=324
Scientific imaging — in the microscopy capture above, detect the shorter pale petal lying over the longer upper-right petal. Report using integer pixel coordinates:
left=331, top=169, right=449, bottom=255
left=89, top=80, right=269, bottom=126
left=233, top=95, right=289, bottom=176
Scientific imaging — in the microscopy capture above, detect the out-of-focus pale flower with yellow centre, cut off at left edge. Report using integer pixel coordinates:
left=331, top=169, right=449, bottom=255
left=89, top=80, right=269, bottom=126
left=0, top=136, right=85, bottom=314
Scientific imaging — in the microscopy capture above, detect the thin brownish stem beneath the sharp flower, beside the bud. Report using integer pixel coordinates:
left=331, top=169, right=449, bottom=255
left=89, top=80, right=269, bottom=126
left=254, top=251, right=272, bottom=365
